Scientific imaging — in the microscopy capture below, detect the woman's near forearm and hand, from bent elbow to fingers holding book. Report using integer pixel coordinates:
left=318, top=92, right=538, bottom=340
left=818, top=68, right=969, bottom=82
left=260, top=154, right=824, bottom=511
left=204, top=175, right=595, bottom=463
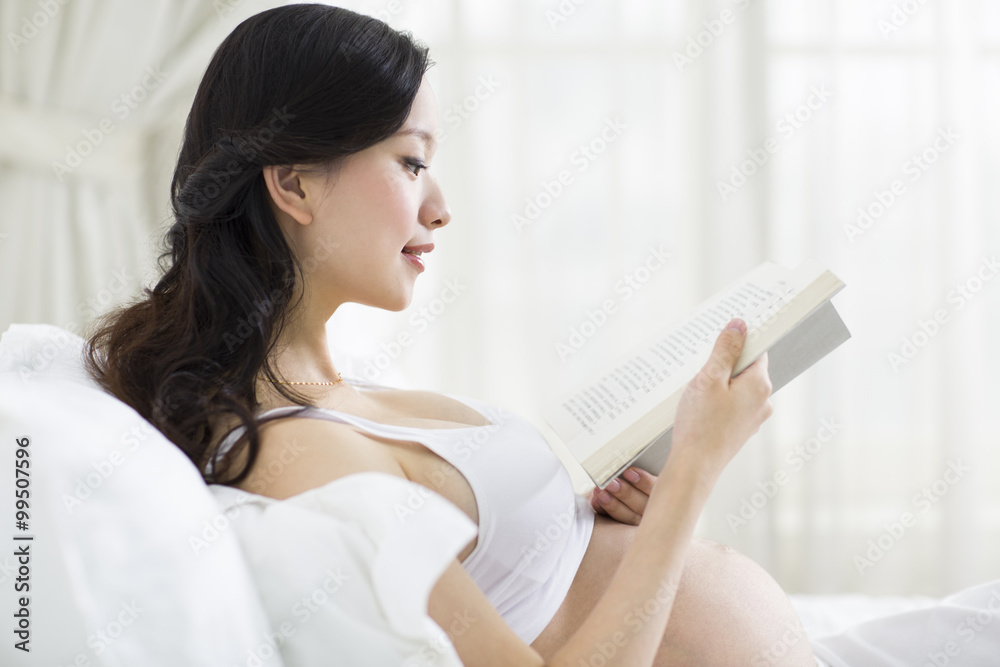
left=429, top=320, right=771, bottom=667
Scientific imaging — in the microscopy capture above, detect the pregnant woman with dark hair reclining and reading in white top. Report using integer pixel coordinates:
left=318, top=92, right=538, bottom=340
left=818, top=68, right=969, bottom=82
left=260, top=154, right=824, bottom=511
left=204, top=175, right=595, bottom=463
left=90, top=4, right=815, bottom=667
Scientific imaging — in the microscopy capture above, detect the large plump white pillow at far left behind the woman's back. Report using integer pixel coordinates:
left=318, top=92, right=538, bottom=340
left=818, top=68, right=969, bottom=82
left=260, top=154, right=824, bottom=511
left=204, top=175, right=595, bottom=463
left=0, top=324, right=282, bottom=667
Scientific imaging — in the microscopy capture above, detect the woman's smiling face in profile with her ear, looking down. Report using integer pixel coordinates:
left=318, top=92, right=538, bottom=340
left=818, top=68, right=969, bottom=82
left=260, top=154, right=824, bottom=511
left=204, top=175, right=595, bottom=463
left=269, top=77, right=451, bottom=314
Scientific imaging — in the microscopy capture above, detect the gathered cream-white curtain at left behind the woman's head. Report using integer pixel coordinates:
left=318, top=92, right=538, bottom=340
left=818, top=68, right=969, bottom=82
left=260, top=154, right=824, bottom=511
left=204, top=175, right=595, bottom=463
left=0, top=0, right=281, bottom=340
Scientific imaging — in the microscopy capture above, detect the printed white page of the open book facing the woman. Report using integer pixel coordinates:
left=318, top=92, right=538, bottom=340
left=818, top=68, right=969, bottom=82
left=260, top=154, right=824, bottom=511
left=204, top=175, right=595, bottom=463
left=543, top=263, right=818, bottom=460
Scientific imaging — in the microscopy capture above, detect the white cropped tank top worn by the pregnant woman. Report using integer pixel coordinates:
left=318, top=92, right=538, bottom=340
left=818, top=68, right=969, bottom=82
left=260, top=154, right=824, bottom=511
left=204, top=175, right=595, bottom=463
left=210, top=379, right=594, bottom=644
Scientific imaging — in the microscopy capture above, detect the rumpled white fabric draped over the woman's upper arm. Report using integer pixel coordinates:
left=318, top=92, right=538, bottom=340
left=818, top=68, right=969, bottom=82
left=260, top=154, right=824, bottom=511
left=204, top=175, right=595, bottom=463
left=210, top=472, right=476, bottom=667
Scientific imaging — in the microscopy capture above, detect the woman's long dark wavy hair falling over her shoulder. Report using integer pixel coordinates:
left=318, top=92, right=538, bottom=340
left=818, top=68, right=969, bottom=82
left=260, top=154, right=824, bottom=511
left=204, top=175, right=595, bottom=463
left=85, top=4, right=432, bottom=485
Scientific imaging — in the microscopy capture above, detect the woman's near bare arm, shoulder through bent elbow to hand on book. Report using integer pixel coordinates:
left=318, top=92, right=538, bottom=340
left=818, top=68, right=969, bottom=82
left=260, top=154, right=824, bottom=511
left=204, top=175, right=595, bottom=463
left=255, top=320, right=771, bottom=667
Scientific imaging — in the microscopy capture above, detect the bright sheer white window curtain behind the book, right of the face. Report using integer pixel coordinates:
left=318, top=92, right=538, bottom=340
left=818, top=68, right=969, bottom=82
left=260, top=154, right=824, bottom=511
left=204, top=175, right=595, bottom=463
left=330, top=0, right=1000, bottom=595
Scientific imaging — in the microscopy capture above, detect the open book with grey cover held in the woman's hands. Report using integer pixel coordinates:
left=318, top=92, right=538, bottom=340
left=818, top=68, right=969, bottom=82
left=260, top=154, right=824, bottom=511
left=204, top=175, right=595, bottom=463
left=542, top=260, right=851, bottom=489
